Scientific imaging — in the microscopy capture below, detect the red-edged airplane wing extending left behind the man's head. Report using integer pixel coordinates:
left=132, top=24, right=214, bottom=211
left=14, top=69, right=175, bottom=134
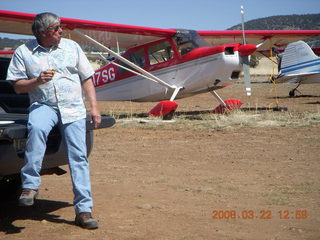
left=0, top=10, right=176, bottom=49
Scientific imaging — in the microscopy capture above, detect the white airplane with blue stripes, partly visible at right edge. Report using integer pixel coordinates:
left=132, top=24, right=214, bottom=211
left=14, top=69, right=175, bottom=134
left=275, top=41, right=320, bottom=97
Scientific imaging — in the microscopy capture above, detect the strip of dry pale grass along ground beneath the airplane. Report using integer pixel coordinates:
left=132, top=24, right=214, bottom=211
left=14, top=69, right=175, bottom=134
left=111, top=110, right=320, bottom=130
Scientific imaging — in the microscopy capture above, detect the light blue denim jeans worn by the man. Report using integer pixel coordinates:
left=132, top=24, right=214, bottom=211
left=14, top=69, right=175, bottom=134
left=21, top=104, right=93, bottom=213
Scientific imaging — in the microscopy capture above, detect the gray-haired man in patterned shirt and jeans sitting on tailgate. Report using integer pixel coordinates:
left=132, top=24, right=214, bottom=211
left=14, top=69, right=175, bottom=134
left=7, top=13, right=101, bottom=229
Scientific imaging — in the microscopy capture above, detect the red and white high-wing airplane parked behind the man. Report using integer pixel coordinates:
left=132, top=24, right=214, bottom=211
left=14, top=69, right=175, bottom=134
left=0, top=10, right=320, bottom=117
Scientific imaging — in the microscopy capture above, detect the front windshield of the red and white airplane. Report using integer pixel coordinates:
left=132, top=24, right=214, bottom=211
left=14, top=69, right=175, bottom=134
left=174, top=30, right=209, bottom=55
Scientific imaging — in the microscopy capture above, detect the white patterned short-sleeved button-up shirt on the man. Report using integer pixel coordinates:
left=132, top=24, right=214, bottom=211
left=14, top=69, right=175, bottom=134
left=7, top=38, right=94, bottom=124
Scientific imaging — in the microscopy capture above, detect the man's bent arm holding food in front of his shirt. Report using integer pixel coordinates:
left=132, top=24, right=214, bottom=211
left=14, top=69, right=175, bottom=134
left=13, top=71, right=54, bottom=93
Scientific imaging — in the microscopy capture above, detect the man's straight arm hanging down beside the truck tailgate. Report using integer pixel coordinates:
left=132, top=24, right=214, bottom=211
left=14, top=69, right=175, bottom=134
left=82, top=77, right=101, bottom=128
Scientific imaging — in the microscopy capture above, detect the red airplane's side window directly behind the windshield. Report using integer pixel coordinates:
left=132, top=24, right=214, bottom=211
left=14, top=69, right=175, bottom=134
left=148, top=41, right=173, bottom=65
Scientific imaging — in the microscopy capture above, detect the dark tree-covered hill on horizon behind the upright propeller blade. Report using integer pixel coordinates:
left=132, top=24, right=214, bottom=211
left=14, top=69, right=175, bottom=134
left=228, top=14, right=320, bottom=47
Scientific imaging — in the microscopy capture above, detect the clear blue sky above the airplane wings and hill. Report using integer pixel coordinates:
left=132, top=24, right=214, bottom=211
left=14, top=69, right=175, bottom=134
left=0, top=0, right=320, bottom=38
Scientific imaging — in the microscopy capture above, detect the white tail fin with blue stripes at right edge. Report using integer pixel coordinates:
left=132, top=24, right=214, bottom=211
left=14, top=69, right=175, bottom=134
left=278, top=41, right=319, bottom=78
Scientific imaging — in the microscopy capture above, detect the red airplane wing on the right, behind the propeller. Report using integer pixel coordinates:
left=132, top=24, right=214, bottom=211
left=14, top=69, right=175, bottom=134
left=198, top=30, right=320, bottom=50
